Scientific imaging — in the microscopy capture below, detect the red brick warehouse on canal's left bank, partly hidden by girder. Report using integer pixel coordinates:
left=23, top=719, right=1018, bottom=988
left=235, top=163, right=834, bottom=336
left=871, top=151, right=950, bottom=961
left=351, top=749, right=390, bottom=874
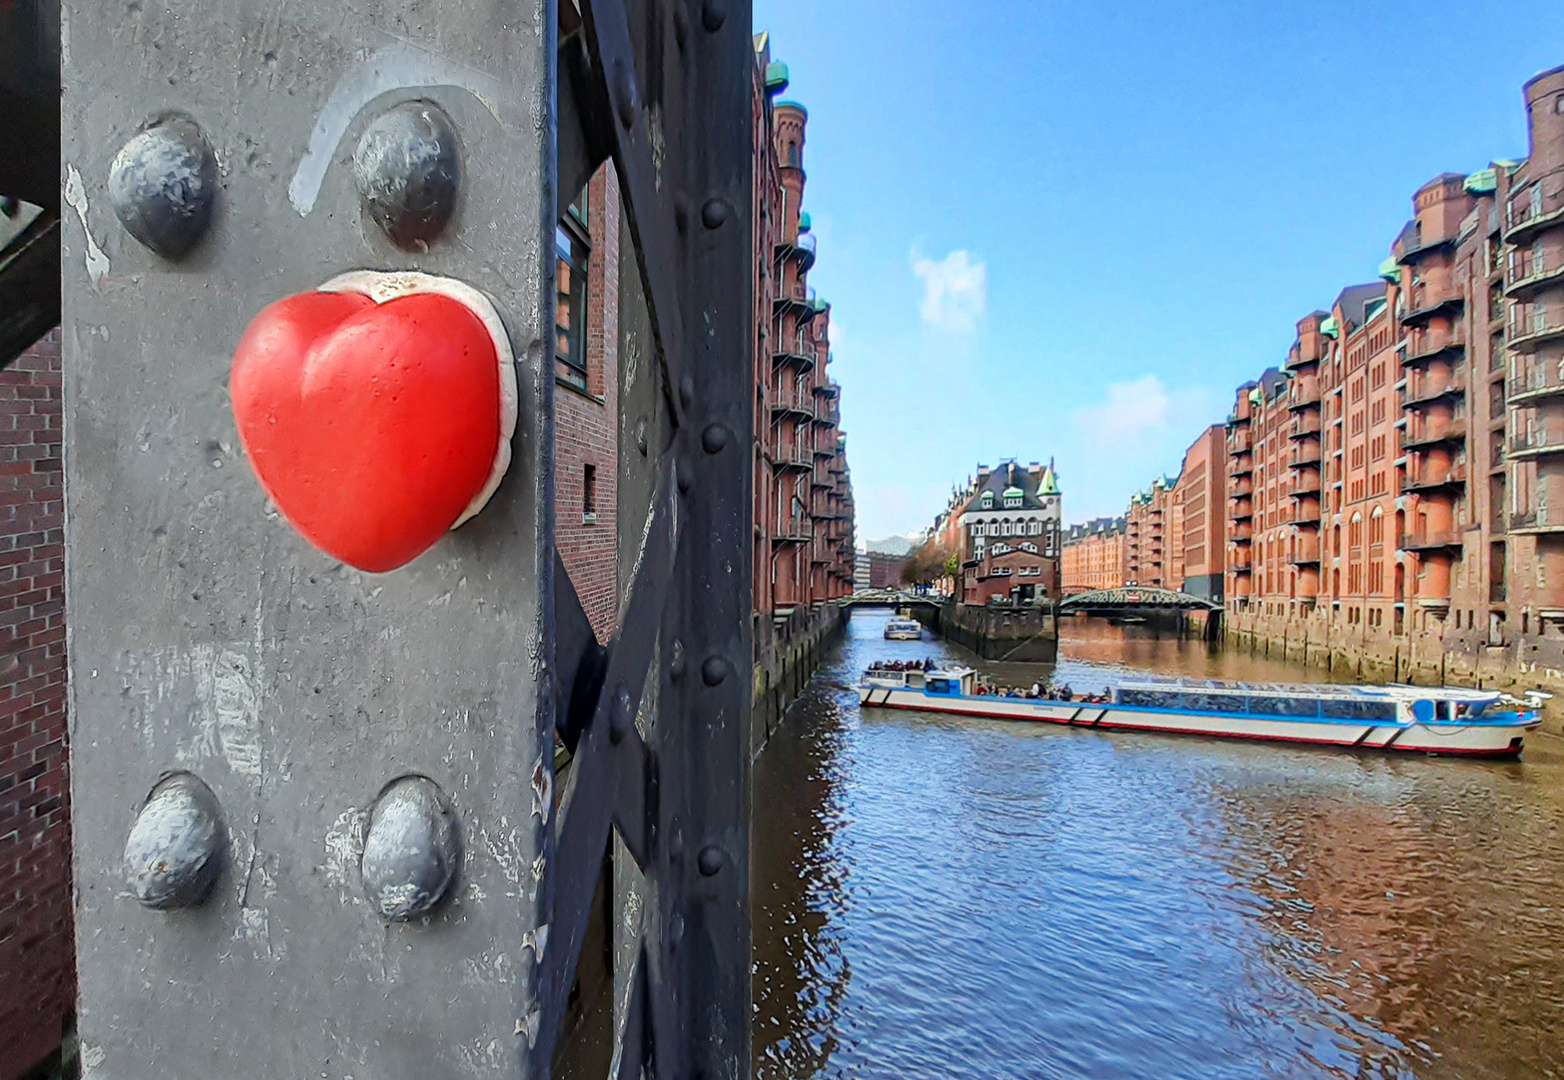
left=554, top=34, right=854, bottom=641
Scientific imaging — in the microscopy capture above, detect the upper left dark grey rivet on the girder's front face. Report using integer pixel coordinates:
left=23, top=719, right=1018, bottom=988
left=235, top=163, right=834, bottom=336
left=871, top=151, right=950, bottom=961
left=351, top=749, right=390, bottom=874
left=108, top=116, right=217, bottom=259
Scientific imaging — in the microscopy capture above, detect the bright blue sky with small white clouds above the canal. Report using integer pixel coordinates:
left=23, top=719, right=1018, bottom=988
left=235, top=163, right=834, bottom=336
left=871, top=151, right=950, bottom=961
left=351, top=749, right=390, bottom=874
left=755, top=0, right=1564, bottom=539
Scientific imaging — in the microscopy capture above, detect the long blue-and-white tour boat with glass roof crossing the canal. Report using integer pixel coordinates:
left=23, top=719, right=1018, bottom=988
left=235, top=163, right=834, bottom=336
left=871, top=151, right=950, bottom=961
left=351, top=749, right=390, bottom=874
left=857, top=666, right=1547, bottom=758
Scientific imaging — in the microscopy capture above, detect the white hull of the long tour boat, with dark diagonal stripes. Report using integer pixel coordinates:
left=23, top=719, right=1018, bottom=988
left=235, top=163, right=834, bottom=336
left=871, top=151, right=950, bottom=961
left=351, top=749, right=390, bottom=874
left=859, top=686, right=1537, bottom=756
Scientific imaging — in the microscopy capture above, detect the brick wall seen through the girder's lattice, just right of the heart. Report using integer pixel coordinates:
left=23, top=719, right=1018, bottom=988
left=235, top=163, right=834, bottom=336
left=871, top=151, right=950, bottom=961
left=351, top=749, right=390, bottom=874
left=554, top=164, right=619, bottom=641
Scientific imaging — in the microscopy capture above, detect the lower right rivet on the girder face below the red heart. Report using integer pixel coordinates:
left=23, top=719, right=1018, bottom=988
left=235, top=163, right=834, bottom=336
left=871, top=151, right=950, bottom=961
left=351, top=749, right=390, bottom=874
left=358, top=777, right=461, bottom=922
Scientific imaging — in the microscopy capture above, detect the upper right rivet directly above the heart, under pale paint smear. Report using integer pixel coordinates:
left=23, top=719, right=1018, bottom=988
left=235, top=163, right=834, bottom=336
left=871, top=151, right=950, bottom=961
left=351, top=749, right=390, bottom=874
left=353, top=102, right=461, bottom=250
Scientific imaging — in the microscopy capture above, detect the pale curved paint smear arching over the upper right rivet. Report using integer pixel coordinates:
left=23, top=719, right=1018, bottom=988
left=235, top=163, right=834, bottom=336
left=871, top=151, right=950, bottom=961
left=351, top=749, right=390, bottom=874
left=288, top=42, right=500, bottom=217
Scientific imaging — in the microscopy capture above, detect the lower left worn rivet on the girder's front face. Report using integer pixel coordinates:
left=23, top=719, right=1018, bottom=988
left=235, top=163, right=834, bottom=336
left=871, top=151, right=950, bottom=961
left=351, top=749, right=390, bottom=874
left=125, top=772, right=228, bottom=911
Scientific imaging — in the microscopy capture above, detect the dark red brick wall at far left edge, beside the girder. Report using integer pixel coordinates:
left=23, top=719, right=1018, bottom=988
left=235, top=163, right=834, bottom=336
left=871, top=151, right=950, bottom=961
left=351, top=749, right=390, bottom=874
left=0, top=330, right=77, bottom=1080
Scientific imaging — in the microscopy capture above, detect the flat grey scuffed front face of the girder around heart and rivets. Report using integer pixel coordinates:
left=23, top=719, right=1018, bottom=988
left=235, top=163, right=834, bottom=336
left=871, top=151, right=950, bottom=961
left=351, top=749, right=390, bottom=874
left=59, top=0, right=557, bottom=1080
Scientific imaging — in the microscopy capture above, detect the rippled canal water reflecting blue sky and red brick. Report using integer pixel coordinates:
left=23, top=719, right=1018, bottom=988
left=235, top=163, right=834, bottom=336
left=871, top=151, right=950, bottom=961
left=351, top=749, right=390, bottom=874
left=754, top=611, right=1564, bottom=1080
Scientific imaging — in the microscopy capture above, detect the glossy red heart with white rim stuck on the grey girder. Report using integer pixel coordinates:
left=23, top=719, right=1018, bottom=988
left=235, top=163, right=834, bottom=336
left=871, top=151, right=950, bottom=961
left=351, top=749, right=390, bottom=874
left=230, top=272, right=516, bottom=572
